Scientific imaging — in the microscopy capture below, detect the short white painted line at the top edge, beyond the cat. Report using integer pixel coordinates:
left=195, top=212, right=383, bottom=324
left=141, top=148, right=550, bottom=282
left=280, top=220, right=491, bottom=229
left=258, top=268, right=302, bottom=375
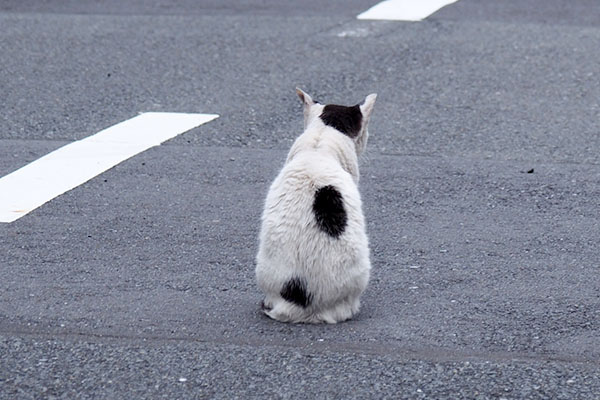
left=356, top=0, right=458, bottom=21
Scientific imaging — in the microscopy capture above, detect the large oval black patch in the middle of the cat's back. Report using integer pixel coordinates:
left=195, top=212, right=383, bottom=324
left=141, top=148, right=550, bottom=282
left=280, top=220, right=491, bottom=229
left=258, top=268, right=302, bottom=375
left=313, top=185, right=348, bottom=238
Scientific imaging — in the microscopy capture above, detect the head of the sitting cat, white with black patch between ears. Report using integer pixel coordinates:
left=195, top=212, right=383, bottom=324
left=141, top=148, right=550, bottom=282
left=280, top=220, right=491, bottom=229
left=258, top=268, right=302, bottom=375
left=296, top=88, right=377, bottom=154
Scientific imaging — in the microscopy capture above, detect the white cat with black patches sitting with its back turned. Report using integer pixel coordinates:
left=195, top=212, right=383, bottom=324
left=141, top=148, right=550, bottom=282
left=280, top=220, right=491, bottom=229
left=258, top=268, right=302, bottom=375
left=256, top=88, right=377, bottom=324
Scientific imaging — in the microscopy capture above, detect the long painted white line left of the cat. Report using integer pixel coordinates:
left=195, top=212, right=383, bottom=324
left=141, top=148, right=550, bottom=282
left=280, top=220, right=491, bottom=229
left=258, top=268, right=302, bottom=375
left=0, top=113, right=218, bottom=222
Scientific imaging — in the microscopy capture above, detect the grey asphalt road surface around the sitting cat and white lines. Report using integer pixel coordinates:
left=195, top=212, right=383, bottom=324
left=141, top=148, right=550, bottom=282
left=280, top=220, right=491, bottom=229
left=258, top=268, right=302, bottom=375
left=0, top=0, right=600, bottom=399
